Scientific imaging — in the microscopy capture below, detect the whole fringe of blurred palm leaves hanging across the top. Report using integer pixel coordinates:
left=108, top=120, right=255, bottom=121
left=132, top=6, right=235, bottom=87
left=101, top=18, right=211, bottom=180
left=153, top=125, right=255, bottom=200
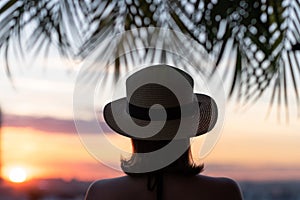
left=0, top=0, right=300, bottom=119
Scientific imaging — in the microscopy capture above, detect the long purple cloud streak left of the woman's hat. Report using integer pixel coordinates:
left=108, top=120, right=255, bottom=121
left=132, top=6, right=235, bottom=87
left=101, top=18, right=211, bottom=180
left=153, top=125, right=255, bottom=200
left=3, top=114, right=112, bottom=133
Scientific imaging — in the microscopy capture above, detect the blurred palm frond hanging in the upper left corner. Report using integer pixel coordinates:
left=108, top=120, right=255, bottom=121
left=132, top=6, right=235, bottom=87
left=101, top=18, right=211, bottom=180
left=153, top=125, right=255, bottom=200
left=0, top=0, right=86, bottom=73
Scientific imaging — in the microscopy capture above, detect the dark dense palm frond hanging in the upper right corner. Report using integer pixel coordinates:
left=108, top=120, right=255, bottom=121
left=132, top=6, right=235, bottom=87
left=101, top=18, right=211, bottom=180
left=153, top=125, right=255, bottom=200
left=169, top=0, right=300, bottom=119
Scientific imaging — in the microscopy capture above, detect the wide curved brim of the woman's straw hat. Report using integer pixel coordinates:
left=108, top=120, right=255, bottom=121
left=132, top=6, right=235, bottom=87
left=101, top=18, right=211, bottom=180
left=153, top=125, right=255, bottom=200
left=103, top=94, right=218, bottom=140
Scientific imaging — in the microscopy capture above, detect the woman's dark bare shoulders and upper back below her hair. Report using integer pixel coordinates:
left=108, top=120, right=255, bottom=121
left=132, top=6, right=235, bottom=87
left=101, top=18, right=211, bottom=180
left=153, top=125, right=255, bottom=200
left=86, top=175, right=242, bottom=200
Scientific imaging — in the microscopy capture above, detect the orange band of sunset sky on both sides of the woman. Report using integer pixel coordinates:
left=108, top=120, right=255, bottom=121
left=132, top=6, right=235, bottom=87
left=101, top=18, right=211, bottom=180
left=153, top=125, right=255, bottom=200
left=2, top=108, right=300, bottom=180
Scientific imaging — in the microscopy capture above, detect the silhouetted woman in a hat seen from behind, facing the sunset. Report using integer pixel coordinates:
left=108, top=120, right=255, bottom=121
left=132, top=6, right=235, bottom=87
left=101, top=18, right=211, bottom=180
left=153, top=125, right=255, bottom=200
left=86, top=65, right=242, bottom=200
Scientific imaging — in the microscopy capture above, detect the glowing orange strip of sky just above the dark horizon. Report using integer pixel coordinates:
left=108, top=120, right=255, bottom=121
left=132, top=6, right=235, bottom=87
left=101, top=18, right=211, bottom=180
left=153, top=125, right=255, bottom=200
left=2, top=122, right=300, bottom=181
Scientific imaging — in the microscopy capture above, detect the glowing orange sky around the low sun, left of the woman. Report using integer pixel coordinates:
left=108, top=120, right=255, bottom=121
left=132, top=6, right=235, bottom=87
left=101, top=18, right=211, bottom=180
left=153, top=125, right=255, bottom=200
left=2, top=127, right=120, bottom=180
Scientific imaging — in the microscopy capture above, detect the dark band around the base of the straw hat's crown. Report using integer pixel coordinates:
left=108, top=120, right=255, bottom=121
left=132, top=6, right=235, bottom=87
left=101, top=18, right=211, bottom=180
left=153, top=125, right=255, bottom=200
left=126, top=103, right=196, bottom=121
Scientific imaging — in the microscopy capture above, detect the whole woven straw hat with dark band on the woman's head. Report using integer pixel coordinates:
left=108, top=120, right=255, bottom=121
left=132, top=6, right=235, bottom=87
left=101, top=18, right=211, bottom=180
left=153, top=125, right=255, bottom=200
left=103, top=65, right=218, bottom=140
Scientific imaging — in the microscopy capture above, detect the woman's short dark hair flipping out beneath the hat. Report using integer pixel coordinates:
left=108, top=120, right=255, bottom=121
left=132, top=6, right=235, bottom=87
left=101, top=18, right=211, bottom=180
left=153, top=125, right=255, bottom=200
left=121, top=139, right=204, bottom=176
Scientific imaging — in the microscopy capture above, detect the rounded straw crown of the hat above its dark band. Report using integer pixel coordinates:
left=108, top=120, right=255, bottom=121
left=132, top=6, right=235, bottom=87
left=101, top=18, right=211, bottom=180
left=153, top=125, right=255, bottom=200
left=126, top=65, right=194, bottom=108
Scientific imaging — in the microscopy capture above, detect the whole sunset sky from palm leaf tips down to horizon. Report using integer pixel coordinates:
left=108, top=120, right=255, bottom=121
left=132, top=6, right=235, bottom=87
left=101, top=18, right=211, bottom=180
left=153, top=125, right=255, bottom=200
left=0, top=48, right=300, bottom=183
